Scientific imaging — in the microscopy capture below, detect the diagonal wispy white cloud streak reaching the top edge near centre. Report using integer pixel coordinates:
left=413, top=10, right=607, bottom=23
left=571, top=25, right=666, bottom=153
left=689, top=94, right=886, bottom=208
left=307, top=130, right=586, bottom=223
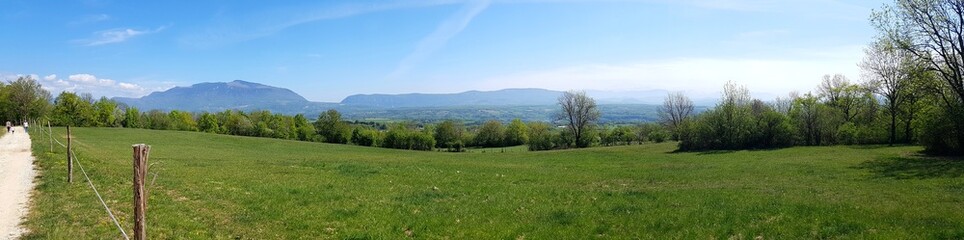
left=388, top=0, right=491, bottom=79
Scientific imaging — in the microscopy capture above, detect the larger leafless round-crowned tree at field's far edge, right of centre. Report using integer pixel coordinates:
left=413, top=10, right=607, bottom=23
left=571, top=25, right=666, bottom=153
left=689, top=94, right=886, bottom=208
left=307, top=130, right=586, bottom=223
left=559, top=90, right=600, bottom=147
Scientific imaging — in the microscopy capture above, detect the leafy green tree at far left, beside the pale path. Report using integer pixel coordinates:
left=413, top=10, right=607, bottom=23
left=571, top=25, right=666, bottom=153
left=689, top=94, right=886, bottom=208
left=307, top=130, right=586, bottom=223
left=7, top=76, right=51, bottom=121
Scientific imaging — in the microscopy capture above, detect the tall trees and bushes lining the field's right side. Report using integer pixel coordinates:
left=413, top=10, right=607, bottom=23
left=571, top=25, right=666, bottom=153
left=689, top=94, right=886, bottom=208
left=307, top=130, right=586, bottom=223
left=661, top=0, right=964, bottom=155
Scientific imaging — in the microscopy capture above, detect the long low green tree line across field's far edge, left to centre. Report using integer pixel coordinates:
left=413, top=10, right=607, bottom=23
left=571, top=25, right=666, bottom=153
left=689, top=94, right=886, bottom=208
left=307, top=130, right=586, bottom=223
left=0, top=79, right=667, bottom=152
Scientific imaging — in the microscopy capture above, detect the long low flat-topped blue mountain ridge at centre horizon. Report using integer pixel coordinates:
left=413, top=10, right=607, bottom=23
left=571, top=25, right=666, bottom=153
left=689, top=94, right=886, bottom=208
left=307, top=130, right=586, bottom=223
left=341, top=88, right=562, bottom=108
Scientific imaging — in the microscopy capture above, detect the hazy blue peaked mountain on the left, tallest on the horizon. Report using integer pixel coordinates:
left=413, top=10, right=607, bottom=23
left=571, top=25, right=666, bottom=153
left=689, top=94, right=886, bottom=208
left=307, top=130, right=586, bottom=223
left=114, top=80, right=330, bottom=112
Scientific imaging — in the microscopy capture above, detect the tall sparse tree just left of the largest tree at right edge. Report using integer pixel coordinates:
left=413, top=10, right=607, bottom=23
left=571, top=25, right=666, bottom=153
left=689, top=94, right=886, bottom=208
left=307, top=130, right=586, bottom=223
left=860, top=39, right=916, bottom=145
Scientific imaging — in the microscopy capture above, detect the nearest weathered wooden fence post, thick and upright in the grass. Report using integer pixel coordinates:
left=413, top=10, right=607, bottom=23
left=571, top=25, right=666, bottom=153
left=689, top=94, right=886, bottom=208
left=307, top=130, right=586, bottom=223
left=132, top=144, right=151, bottom=240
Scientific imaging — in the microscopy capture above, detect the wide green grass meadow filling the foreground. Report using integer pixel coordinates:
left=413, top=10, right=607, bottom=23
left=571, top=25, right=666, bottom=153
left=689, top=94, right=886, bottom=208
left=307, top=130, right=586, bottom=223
left=24, top=128, right=964, bottom=239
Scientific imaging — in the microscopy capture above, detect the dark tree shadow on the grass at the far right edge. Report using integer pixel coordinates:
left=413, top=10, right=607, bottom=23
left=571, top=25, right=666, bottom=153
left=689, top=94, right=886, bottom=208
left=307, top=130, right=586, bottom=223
left=855, top=155, right=964, bottom=179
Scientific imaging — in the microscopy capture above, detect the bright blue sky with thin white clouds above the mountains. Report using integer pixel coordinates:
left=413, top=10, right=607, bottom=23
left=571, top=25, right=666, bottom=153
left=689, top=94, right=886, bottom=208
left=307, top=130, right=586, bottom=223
left=0, top=0, right=883, bottom=101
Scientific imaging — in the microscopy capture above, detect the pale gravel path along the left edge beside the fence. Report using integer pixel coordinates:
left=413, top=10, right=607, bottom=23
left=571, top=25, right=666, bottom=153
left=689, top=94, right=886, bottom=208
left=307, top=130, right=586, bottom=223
left=0, top=127, right=36, bottom=239
